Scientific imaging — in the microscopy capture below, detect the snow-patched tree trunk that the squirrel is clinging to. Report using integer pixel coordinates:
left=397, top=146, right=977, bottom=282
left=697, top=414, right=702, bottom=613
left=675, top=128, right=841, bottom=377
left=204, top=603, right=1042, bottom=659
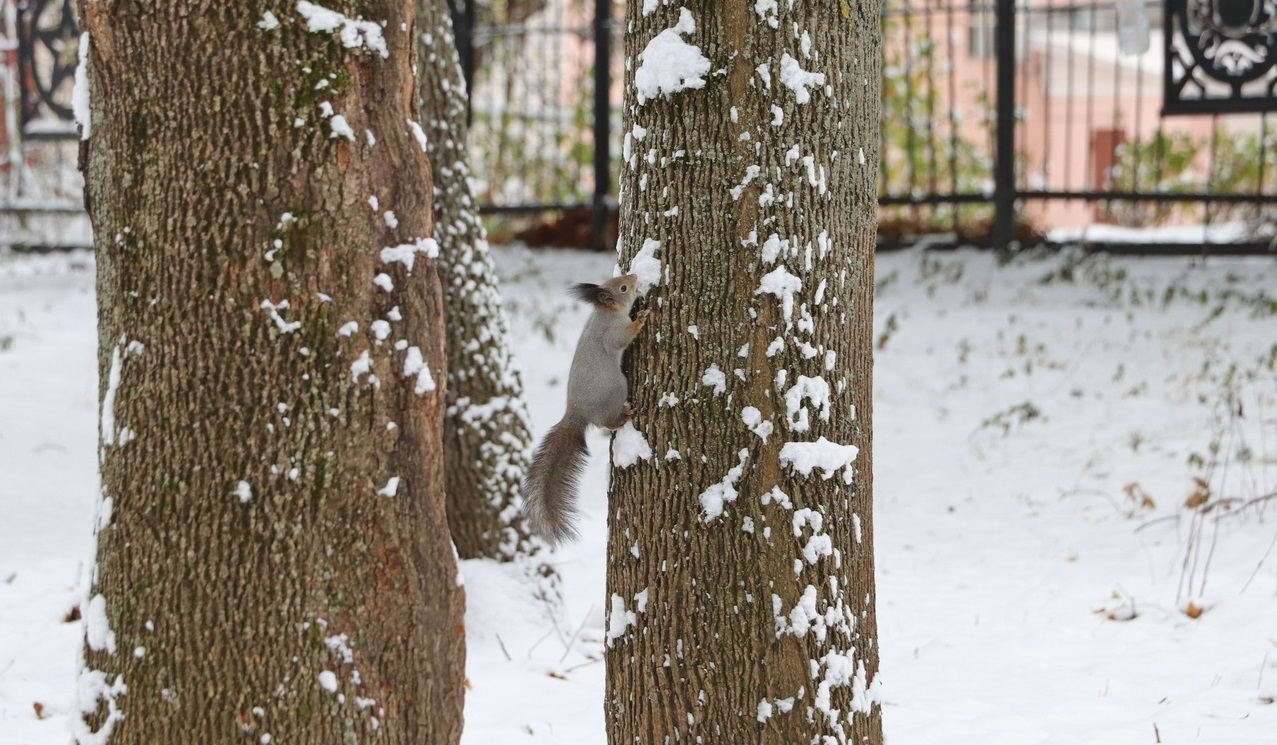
left=607, top=0, right=882, bottom=745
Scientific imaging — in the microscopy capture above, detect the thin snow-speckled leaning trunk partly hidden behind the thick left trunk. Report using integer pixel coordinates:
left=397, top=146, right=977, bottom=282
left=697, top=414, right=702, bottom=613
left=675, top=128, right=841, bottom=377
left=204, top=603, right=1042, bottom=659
left=416, top=0, right=539, bottom=561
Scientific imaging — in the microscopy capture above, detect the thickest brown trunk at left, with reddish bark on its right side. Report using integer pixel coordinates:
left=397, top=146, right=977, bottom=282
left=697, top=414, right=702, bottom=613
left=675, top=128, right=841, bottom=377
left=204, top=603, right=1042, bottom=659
left=77, top=0, right=465, bottom=745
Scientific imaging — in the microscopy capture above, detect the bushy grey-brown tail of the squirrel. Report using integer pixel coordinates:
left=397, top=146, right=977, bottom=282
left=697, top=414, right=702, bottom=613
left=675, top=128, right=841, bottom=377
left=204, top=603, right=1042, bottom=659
left=524, top=417, right=590, bottom=544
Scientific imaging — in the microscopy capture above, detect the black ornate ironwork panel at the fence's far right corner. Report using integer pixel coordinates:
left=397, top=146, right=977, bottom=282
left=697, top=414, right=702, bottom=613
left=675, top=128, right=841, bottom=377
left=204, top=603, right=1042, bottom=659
left=1162, top=0, right=1277, bottom=114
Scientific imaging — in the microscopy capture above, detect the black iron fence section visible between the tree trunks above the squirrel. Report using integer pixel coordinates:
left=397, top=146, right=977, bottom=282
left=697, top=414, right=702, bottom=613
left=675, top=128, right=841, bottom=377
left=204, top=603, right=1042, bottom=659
left=448, top=0, right=621, bottom=243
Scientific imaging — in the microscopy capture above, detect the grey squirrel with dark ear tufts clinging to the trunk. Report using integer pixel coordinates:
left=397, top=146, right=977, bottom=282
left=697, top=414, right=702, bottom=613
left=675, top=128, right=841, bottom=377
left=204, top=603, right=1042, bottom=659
left=524, top=275, right=649, bottom=546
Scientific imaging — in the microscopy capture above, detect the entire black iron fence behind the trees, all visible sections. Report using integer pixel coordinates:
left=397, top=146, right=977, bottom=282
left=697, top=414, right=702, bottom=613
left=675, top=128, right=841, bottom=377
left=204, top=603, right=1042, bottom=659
left=0, top=0, right=1277, bottom=250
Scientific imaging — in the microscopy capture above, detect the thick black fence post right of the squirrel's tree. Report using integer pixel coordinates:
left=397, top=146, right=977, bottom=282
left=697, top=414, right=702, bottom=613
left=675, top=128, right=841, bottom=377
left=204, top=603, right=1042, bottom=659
left=994, top=0, right=1015, bottom=248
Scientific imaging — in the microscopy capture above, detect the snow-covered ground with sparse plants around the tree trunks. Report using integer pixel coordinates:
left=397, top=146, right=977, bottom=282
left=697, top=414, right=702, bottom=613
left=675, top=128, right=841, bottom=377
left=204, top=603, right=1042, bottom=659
left=0, top=248, right=1277, bottom=745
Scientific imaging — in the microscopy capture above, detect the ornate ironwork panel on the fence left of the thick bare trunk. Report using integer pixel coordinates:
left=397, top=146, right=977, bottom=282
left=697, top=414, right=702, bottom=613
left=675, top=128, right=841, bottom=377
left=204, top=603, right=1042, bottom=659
left=18, top=0, right=79, bottom=137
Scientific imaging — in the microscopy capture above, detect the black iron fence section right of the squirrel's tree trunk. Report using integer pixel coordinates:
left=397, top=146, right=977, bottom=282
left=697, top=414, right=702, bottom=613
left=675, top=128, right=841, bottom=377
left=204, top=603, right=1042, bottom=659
left=880, top=0, right=1277, bottom=250
